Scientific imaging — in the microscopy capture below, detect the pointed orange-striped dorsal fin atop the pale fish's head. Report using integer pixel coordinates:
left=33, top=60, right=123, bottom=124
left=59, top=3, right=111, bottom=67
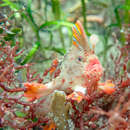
left=72, top=20, right=90, bottom=51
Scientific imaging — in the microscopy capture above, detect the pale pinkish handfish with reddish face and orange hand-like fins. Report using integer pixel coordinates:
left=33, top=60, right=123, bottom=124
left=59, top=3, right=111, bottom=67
left=24, top=21, right=115, bottom=102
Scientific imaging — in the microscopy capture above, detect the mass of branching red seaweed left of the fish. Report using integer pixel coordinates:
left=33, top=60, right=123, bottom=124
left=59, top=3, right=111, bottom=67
left=0, top=41, right=48, bottom=130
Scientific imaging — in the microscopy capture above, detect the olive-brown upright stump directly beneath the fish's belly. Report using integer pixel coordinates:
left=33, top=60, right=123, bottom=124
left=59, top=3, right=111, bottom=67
left=50, top=91, right=74, bottom=130
